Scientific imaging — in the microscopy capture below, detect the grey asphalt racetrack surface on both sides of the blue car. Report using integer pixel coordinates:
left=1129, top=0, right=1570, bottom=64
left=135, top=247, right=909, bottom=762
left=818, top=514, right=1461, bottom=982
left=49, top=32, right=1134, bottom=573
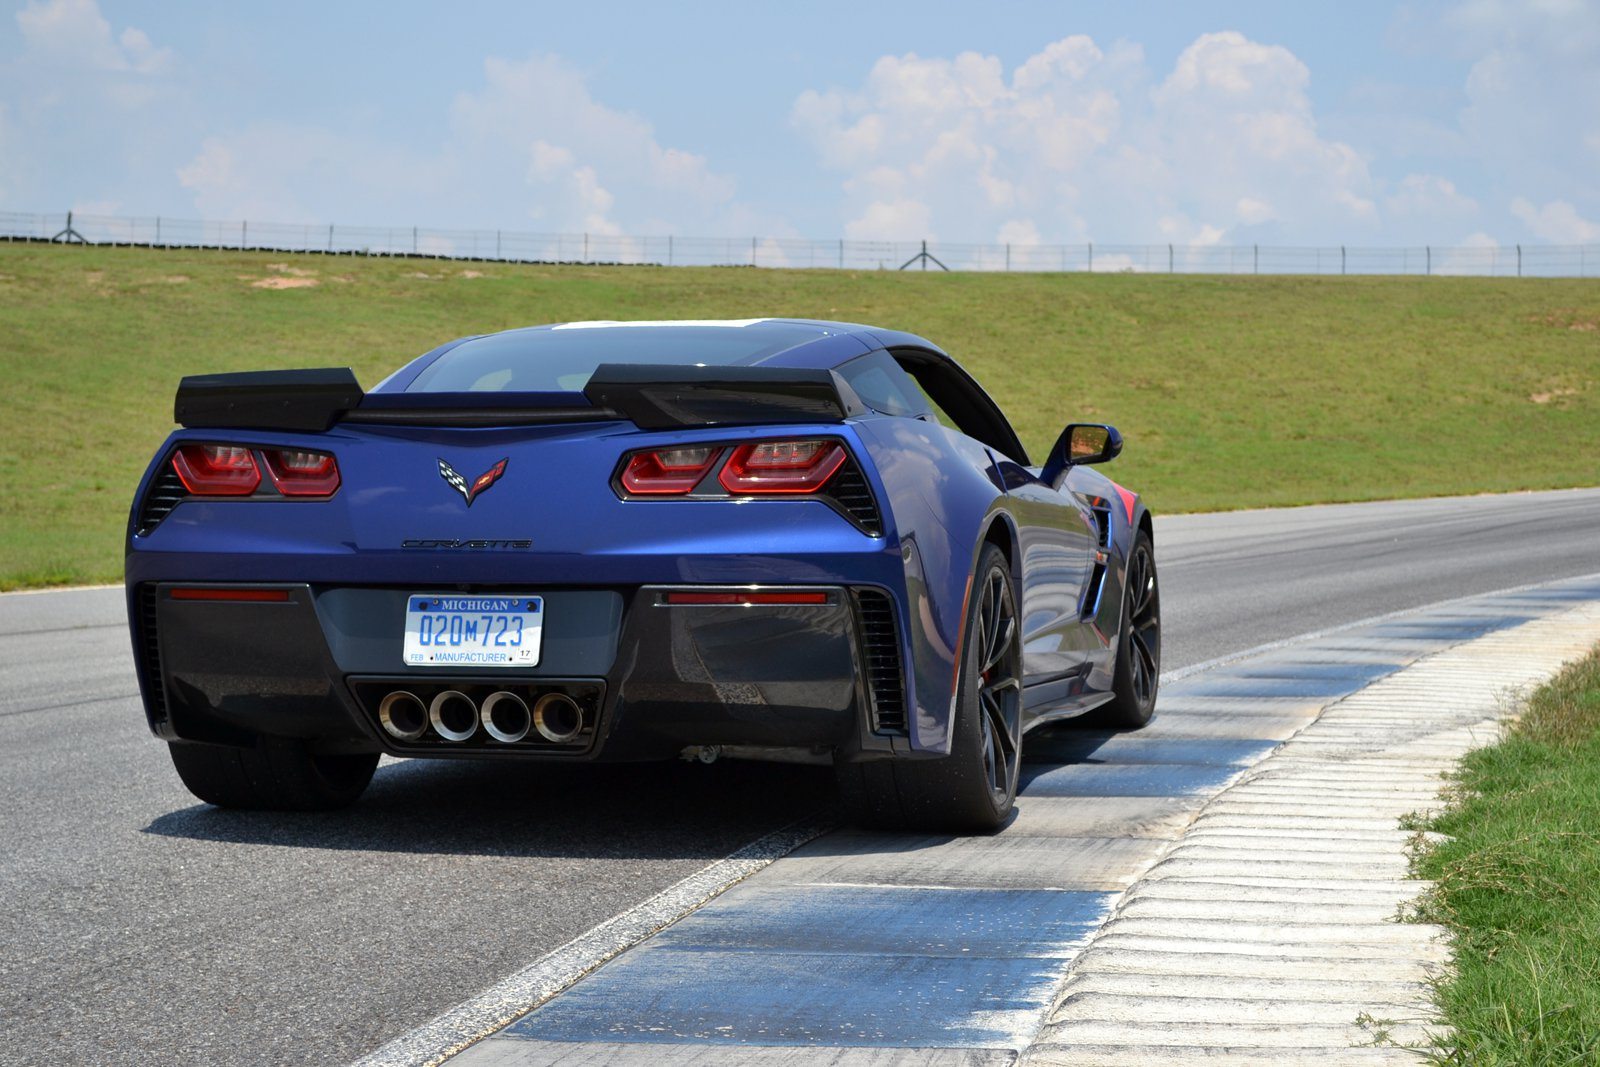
left=0, top=490, right=1600, bottom=1064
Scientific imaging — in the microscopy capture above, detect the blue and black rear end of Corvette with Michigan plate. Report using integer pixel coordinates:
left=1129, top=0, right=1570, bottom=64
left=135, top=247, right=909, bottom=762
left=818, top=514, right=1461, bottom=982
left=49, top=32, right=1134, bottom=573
left=126, top=331, right=928, bottom=809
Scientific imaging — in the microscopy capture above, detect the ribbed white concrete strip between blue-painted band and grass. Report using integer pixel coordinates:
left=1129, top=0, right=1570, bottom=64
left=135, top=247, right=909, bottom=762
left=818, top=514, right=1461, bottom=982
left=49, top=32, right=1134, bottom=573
left=1022, top=605, right=1600, bottom=1067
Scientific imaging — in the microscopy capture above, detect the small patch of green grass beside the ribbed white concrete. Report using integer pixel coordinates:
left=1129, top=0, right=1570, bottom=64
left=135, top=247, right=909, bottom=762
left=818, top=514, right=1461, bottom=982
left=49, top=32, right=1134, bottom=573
left=1418, top=649, right=1600, bottom=1067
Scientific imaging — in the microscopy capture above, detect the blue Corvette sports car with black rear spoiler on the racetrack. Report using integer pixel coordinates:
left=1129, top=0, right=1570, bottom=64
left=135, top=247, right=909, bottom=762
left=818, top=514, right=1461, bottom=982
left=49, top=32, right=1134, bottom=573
left=126, top=318, right=1162, bottom=830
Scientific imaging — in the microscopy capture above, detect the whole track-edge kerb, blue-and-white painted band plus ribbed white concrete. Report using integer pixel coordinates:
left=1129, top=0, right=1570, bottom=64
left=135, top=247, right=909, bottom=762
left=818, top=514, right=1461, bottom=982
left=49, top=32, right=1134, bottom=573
left=390, top=576, right=1600, bottom=1067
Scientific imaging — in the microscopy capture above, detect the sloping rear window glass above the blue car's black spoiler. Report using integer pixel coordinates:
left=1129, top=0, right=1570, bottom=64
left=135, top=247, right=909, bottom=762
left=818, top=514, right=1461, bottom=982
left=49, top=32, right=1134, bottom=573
left=406, top=322, right=827, bottom=392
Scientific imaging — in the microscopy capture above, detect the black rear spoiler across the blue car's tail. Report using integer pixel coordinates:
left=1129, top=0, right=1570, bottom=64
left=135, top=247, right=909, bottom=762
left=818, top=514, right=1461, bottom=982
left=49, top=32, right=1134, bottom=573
left=173, top=363, right=864, bottom=434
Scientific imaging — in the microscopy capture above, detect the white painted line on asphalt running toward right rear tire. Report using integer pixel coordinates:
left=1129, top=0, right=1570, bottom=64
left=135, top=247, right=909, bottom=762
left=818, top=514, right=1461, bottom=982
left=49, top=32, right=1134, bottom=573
left=352, top=813, right=837, bottom=1067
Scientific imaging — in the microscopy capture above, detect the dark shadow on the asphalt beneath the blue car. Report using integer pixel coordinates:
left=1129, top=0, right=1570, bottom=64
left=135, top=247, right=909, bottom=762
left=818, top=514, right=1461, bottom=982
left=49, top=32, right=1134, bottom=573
left=144, top=760, right=837, bottom=859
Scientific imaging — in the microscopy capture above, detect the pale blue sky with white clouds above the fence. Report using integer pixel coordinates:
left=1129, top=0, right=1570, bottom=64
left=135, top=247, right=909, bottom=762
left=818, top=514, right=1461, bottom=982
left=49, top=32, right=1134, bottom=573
left=0, top=0, right=1600, bottom=245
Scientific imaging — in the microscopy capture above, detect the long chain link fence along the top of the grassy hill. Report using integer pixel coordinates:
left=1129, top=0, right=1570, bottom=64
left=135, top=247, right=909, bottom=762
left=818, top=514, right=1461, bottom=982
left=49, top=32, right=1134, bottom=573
left=0, top=213, right=1600, bottom=277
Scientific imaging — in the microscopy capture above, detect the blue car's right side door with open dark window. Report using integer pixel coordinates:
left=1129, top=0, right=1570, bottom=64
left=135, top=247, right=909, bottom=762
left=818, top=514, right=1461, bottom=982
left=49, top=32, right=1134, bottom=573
left=893, top=349, right=1101, bottom=686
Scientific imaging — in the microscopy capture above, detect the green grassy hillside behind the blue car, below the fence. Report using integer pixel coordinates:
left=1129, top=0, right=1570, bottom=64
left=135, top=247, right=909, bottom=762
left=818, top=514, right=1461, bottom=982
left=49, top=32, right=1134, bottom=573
left=0, top=245, right=1600, bottom=587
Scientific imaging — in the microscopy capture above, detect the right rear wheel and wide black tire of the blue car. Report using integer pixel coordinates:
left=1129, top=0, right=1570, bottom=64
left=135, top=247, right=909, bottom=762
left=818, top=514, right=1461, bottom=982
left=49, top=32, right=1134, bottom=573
left=837, top=545, right=1022, bottom=833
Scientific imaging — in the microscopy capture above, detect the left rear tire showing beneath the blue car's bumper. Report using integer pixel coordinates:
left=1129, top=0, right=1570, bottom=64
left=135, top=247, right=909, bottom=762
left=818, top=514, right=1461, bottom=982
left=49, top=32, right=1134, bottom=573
left=166, top=737, right=378, bottom=811
